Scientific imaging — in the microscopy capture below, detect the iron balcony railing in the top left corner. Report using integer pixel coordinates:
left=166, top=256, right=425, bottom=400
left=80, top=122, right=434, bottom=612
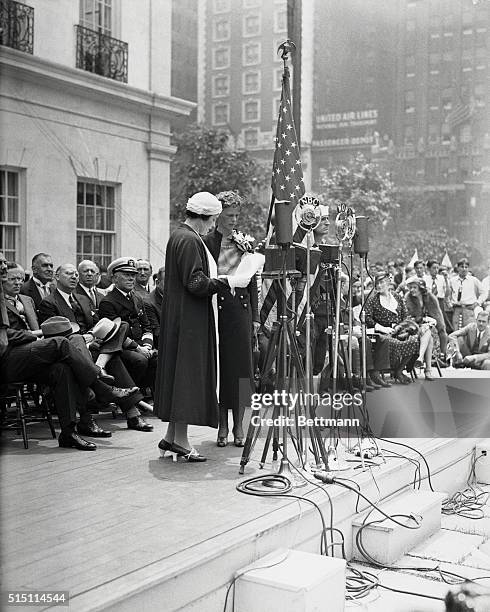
left=0, top=0, right=34, bottom=55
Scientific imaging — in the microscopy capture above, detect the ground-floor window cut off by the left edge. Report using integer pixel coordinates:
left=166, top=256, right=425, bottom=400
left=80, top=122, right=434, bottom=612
left=0, top=169, right=20, bottom=261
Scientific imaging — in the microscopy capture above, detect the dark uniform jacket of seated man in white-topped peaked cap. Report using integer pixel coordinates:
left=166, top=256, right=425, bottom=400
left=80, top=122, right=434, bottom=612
left=99, top=287, right=153, bottom=345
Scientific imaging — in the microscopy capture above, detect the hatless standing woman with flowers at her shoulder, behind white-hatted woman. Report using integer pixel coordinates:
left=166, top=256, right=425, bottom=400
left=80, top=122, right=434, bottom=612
left=204, top=191, right=260, bottom=447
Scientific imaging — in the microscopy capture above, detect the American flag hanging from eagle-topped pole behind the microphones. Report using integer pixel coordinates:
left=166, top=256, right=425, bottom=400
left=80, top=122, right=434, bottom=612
left=260, top=67, right=316, bottom=328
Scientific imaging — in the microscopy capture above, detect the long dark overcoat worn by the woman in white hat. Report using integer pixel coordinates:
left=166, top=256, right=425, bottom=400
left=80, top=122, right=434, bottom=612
left=154, top=223, right=220, bottom=427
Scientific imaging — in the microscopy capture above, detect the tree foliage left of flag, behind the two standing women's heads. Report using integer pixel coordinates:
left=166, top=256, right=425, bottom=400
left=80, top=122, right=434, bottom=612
left=170, top=124, right=270, bottom=235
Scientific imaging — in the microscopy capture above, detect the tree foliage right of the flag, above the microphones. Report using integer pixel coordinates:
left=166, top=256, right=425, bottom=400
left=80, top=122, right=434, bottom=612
left=321, top=153, right=398, bottom=226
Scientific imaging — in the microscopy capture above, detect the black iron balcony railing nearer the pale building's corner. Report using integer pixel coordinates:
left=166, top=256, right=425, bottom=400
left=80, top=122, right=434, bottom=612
left=75, top=25, right=128, bottom=83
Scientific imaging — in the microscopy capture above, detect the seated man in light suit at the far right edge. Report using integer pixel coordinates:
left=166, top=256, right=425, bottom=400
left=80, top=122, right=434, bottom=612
left=449, top=311, right=490, bottom=370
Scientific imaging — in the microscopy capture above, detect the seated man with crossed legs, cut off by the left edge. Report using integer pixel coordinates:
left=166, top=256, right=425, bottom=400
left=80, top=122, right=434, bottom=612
left=0, top=253, right=142, bottom=450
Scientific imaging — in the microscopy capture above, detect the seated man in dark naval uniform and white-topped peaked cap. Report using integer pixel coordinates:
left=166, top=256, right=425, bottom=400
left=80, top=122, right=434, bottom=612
left=99, top=257, right=156, bottom=387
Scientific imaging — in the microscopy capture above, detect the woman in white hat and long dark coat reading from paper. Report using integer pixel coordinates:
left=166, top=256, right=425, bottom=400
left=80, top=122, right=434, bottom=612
left=155, top=192, right=226, bottom=461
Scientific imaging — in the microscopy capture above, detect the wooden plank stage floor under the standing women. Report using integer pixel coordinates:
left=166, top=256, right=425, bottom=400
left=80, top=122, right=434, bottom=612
left=0, top=366, right=488, bottom=610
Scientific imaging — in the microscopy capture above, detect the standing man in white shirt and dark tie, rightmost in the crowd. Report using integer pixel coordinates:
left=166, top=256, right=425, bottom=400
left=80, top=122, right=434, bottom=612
left=449, top=258, right=486, bottom=330
